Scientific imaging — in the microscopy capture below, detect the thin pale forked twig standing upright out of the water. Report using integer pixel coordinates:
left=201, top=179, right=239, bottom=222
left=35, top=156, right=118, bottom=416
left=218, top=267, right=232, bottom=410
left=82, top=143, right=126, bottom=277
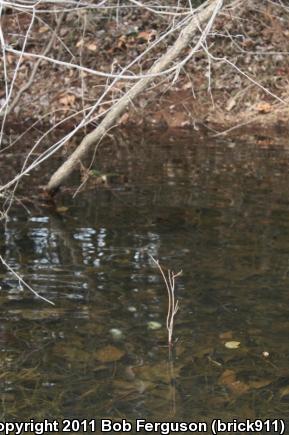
left=150, top=255, right=182, bottom=347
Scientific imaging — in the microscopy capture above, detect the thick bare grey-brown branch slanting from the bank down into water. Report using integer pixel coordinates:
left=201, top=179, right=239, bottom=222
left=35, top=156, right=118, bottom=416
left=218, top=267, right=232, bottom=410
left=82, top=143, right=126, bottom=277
left=47, top=0, right=223, bottom=193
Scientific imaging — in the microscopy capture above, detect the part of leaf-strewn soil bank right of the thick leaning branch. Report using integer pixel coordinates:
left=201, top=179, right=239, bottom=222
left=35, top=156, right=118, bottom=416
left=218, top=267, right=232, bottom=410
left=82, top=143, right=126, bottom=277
left=134, top=1, right=289, bottom=134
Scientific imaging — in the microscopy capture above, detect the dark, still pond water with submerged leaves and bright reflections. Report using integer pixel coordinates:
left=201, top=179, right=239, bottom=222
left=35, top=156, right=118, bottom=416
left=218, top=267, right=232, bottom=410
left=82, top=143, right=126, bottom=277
left=0, top=133, right=289, bottom=433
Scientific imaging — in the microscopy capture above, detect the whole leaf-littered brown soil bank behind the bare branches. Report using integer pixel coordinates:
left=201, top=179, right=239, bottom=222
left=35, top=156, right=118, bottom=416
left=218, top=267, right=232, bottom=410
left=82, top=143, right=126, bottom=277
left=0, top=0, right=289, bottom=134
